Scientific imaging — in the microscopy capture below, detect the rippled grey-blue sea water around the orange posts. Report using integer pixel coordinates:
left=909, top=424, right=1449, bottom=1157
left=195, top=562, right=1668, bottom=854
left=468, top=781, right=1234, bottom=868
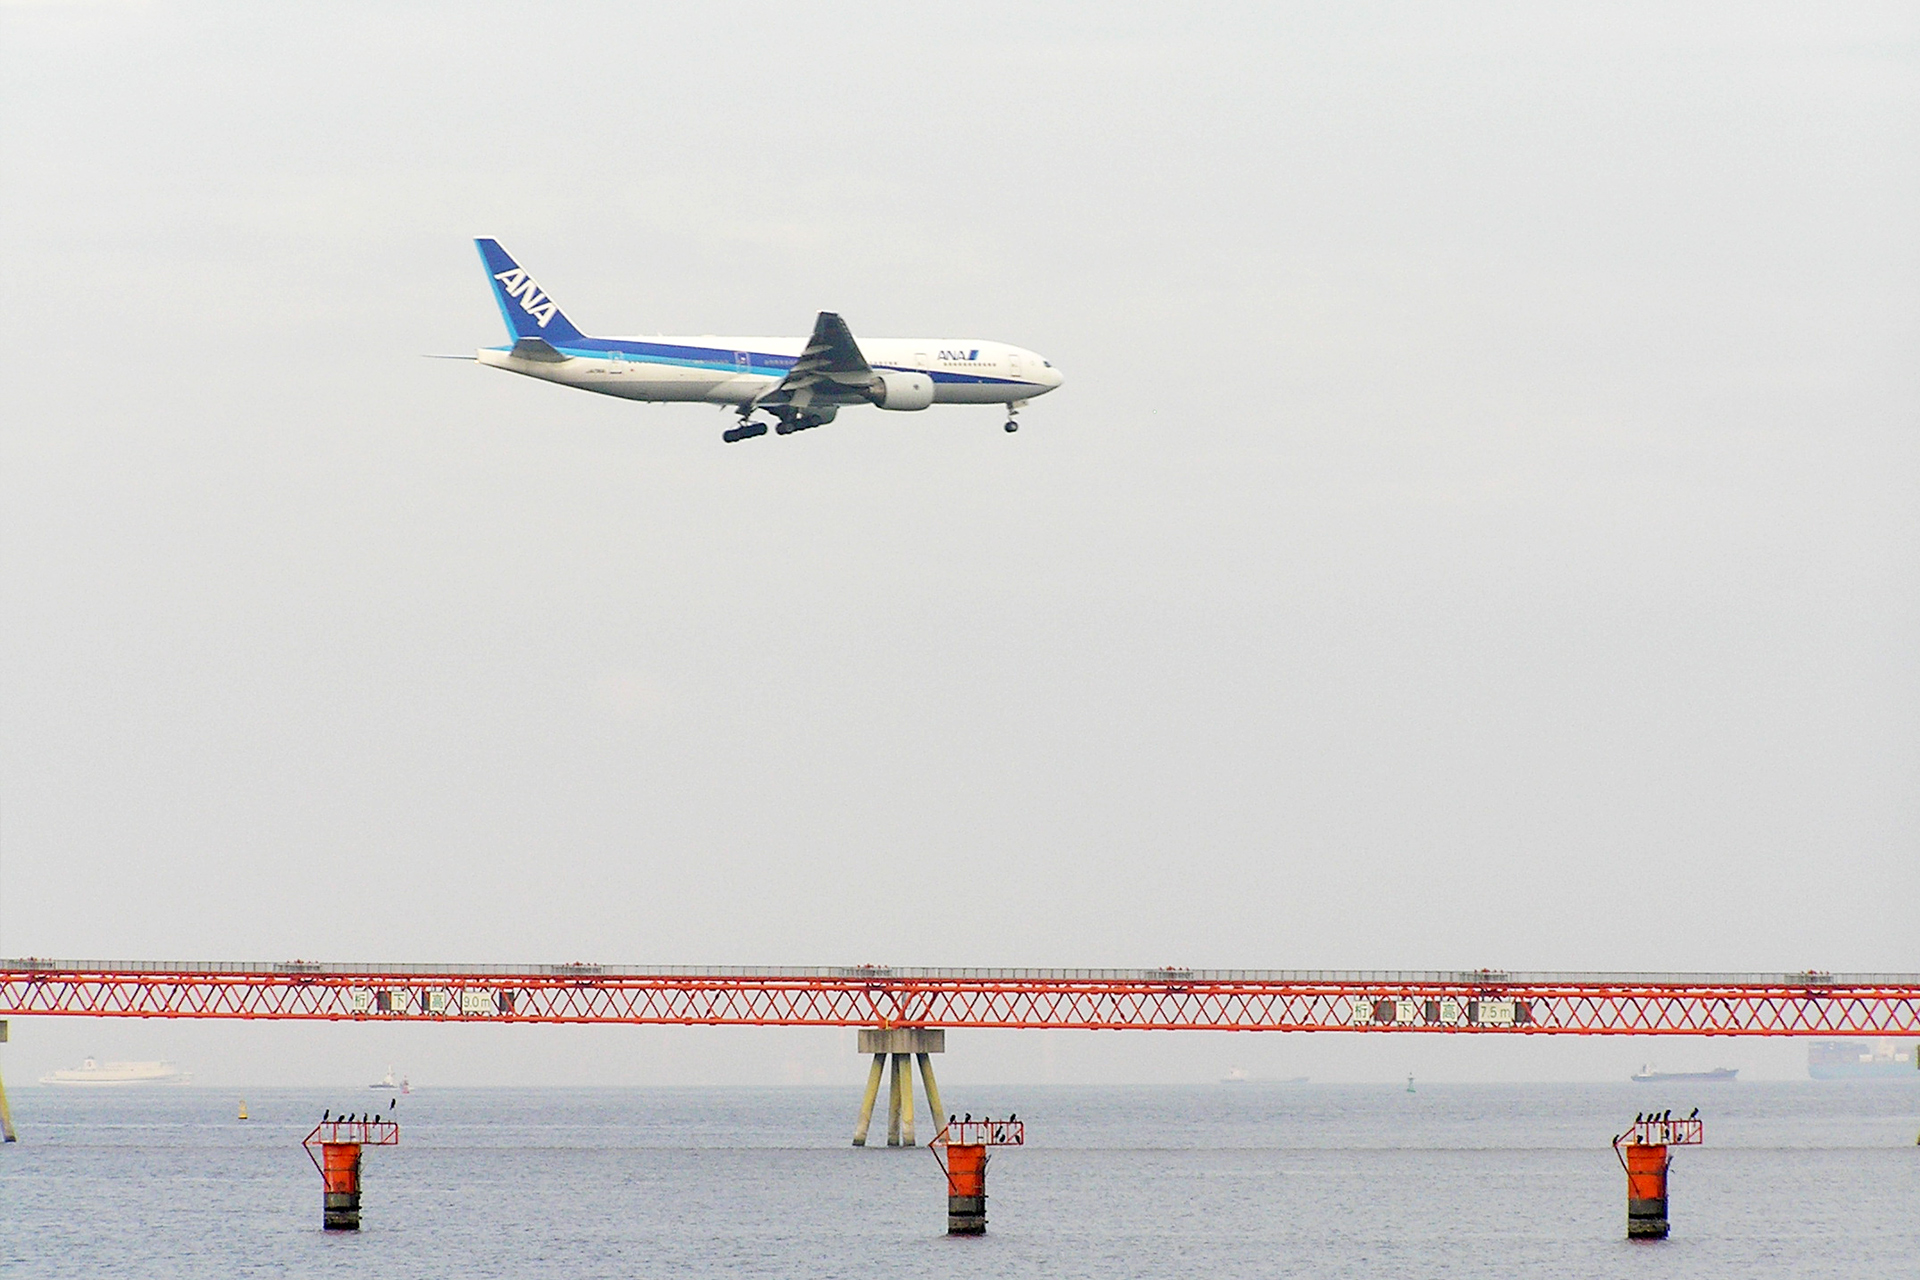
left=0, top=1082, right=1920, bottom=1280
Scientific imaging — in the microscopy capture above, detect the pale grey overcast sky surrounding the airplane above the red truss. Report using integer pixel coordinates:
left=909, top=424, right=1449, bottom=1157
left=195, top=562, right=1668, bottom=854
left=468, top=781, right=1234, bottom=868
left=0, top=4, right=1920, bottom=1084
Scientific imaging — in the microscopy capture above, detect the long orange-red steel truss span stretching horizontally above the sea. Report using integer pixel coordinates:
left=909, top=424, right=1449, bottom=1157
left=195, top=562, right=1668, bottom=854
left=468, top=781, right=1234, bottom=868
left=0, top=958, right=1920, bottom=1036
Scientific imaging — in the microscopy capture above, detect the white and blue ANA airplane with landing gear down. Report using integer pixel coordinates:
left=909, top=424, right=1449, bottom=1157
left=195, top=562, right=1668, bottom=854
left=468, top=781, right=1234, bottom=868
left=474, top=240, right=1060, bottom=443
